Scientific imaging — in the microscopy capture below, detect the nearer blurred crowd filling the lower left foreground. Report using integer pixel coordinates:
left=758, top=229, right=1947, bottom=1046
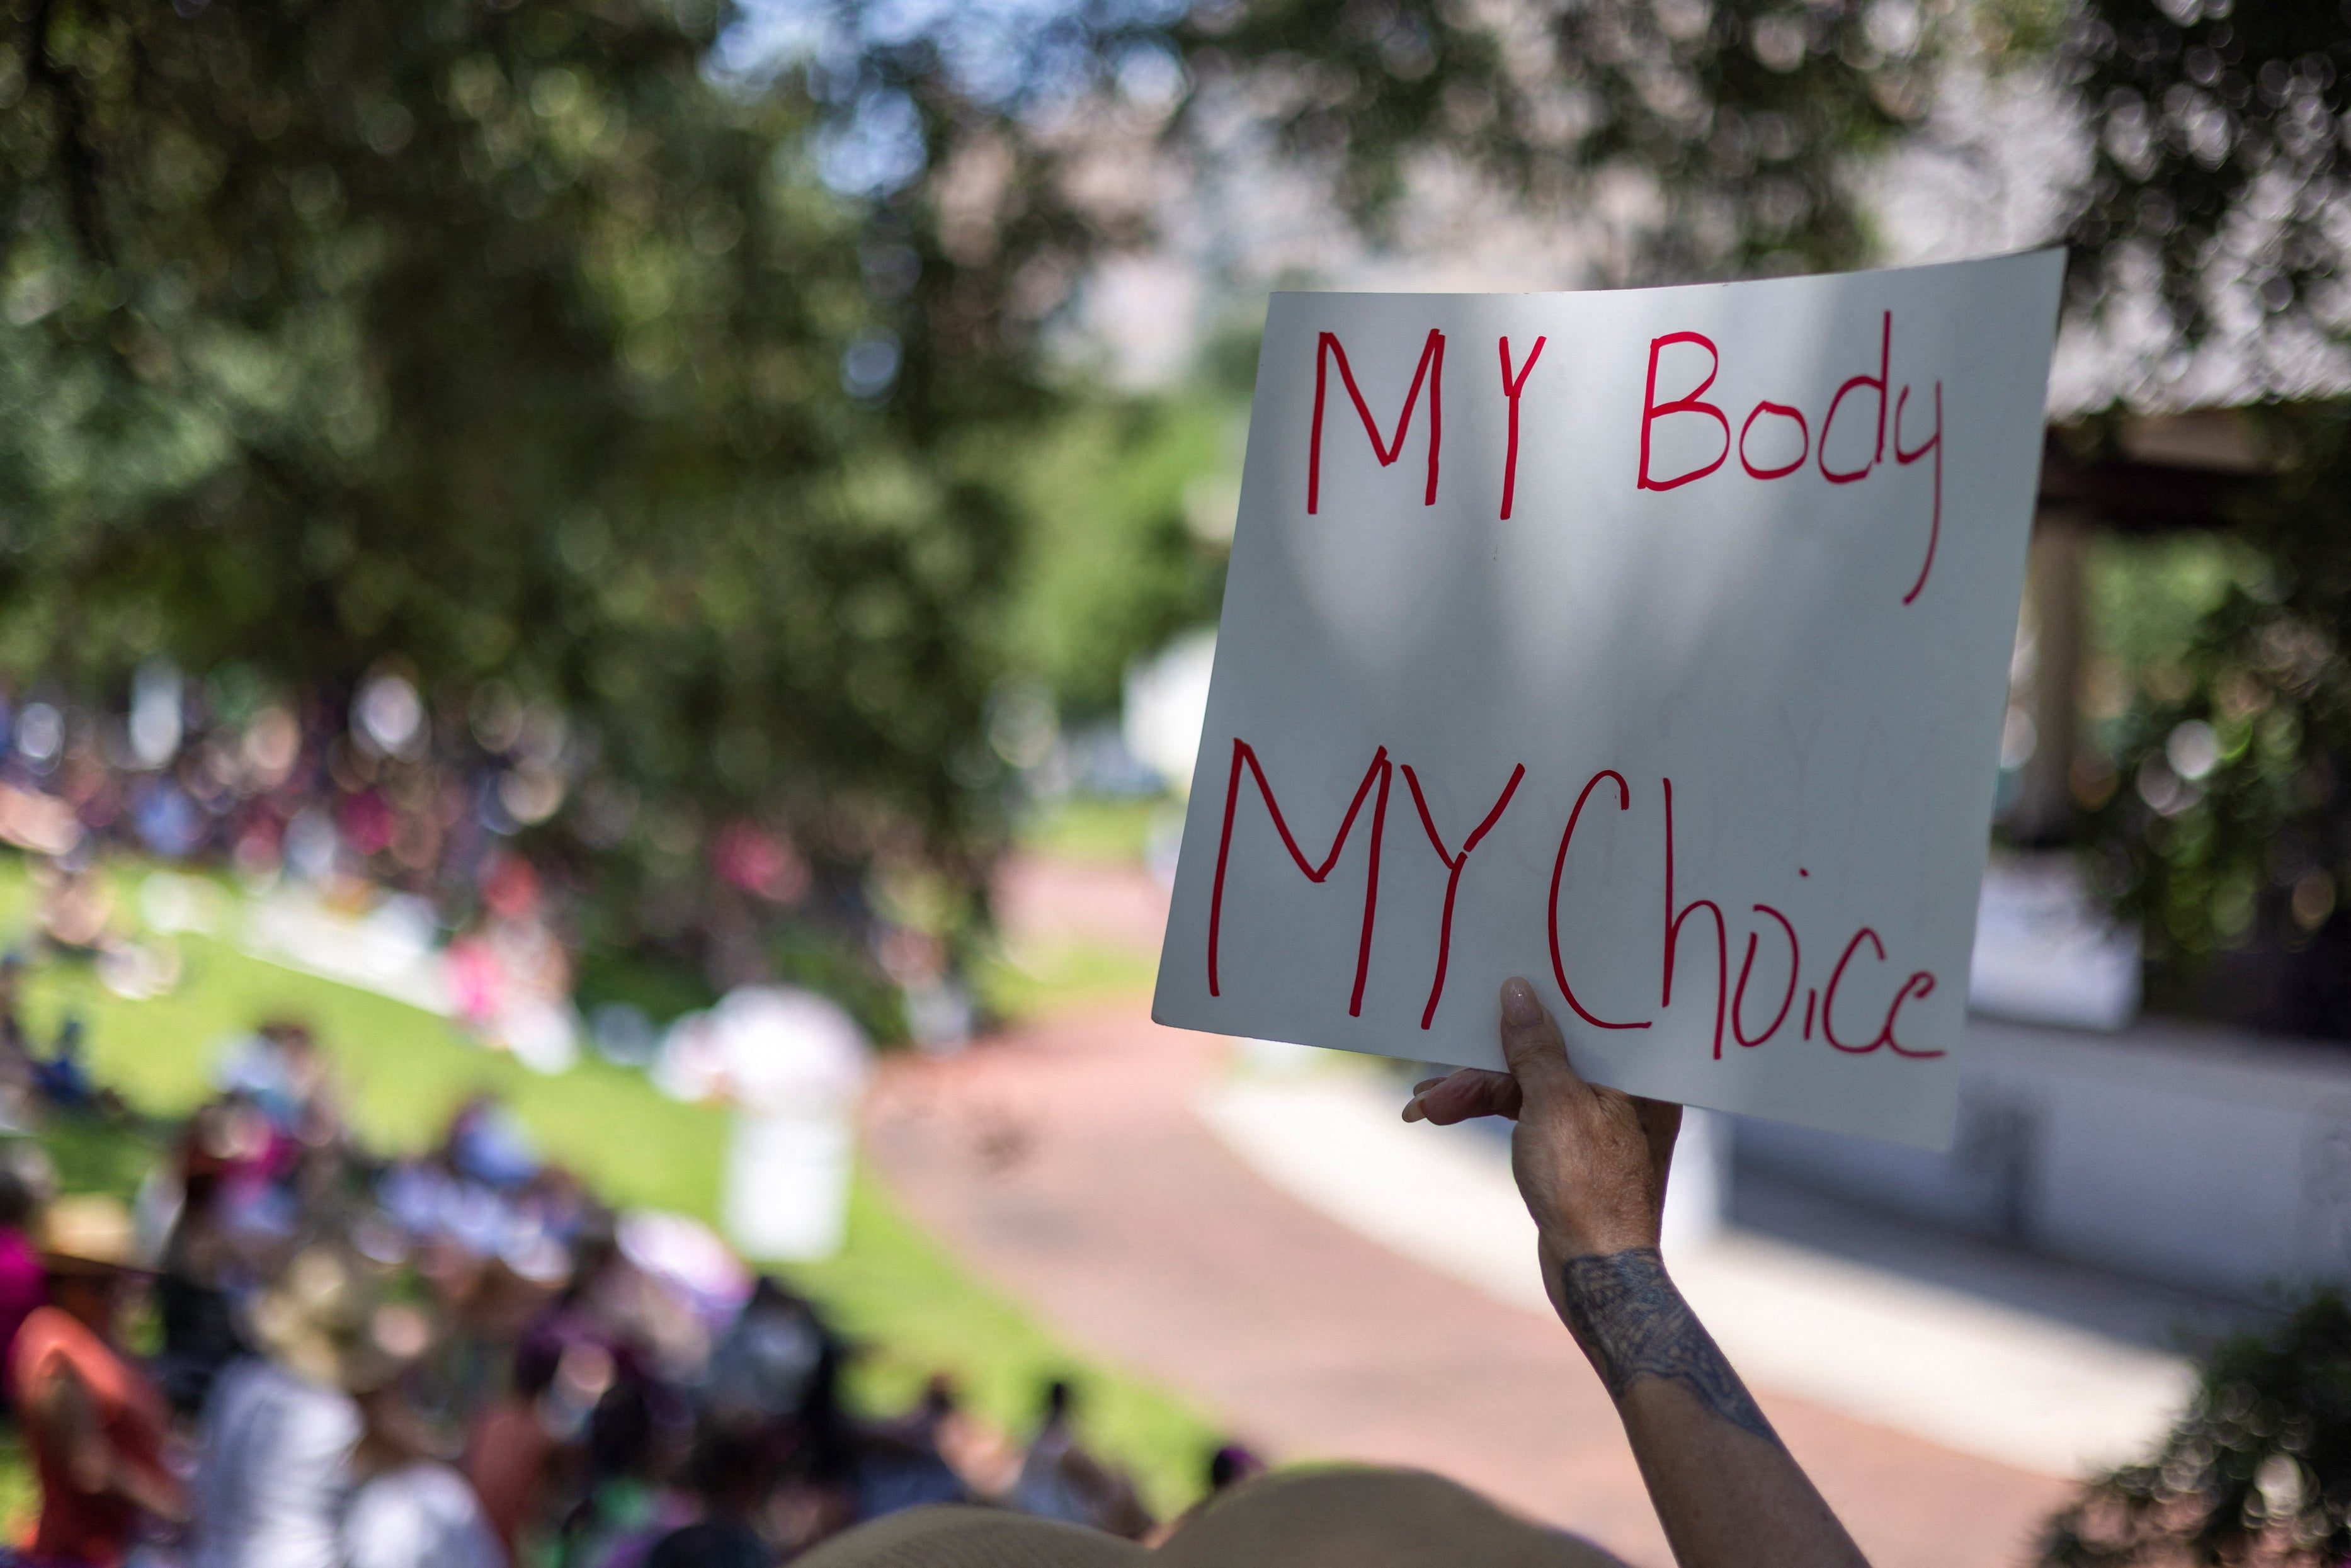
left=0, top=1006, right=1253, bottom=1568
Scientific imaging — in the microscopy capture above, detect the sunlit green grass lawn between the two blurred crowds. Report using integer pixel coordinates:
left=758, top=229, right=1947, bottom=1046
left=0, top=858, right=1218, bottom=1514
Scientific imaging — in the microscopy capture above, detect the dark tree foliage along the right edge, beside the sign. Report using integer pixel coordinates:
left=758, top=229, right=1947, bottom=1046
left=2020, top=0, right=2351, bottom=1037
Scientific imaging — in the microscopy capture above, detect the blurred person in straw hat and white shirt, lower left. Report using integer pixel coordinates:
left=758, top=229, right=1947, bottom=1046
left=188, top=1246, right=374, bottom=1568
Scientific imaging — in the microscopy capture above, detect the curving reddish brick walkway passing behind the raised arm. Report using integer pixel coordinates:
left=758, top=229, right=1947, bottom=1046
left=870, top=1001, right=2069, bottom=1568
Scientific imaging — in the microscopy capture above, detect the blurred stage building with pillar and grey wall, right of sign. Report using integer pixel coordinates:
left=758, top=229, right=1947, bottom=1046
left=1735, top=409, right=2351, bottom=1298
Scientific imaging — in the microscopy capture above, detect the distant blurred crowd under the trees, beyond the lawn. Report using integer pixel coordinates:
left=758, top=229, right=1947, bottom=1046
left=0, top=658, right=973, bottom=1072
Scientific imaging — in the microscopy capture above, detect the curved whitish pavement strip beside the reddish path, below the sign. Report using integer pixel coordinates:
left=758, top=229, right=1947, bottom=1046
left=1194, top=1067, right=2196, bottom=1476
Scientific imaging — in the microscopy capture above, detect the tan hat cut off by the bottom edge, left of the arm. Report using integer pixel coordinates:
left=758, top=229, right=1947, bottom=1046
left=795, top=1469, right=1622, bottom=1568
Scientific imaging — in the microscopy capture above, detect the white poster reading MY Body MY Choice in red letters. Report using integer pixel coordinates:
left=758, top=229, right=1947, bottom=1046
left=1152, top=251, right=2064, bottom=1145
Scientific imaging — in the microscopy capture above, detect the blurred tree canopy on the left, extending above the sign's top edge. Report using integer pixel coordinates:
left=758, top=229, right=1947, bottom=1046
left=0, top=0, right=1921, bottom=907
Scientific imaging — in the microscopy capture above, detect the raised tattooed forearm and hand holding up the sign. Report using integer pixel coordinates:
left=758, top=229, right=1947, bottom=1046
left=1404, top=980, right=1867, bottom=1568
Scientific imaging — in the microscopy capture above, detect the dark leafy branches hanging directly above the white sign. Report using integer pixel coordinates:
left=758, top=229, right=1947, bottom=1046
left=1178, top=0, right=1937, bottom=285
